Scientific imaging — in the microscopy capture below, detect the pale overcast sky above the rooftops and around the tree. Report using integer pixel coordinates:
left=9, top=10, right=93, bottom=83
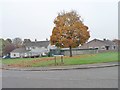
left=0, top=0, right=118, bottom=40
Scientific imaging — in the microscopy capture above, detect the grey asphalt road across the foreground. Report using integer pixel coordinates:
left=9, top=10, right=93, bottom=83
left=2, top=66, right=118, bottom=88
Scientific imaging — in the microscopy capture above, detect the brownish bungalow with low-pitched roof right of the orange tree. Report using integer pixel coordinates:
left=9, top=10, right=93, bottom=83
left=79, top=39, right=118, bottom=50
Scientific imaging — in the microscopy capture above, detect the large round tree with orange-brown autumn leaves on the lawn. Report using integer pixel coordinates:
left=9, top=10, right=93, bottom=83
left=50, top=11, right=90, bottom=57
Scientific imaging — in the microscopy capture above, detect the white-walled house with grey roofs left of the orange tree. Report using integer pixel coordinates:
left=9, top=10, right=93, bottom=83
left=10, top=40, right=50, bottom=58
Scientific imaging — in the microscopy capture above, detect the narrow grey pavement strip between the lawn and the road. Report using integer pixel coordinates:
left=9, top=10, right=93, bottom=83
left=2, top=62, right=119, bottom=71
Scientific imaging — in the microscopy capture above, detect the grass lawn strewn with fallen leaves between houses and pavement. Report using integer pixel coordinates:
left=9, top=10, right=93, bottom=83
left=2, top=52, right=118, bottom=67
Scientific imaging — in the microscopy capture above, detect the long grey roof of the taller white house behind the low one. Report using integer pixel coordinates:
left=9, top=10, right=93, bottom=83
left=24, top=41, right=50, bottom=47
